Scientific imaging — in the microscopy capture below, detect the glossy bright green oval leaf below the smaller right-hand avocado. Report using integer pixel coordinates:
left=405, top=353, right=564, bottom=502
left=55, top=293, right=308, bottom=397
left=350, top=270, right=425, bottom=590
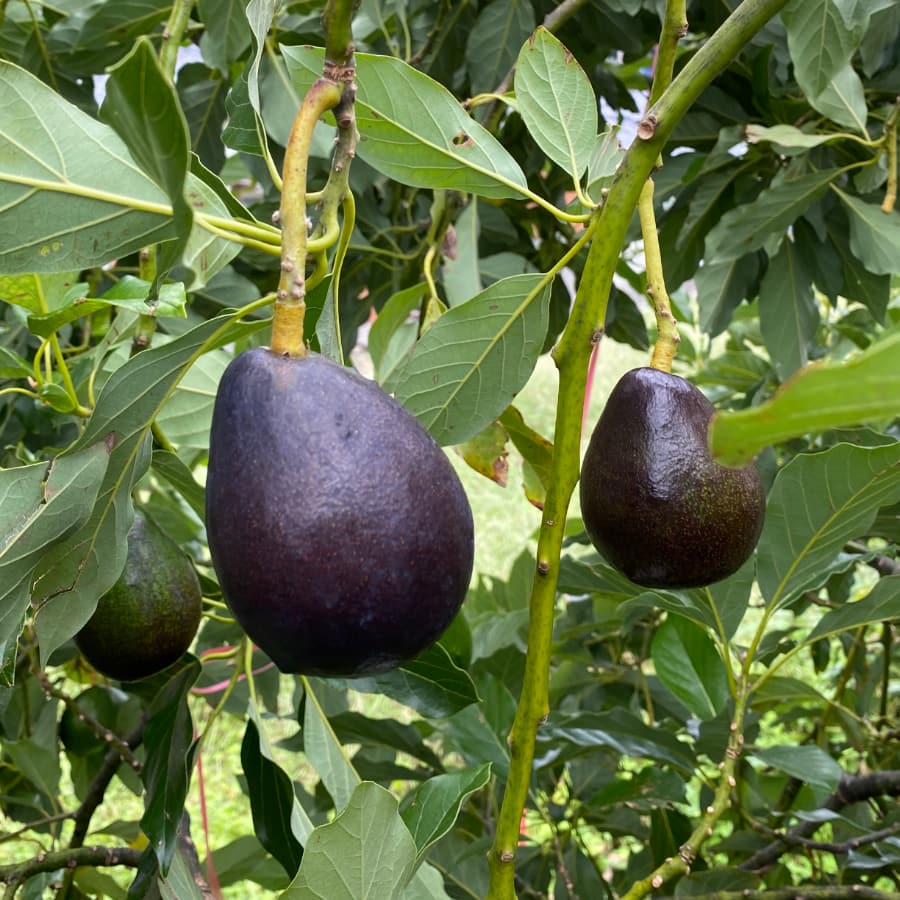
left=650, top=616, right=729, bottom=720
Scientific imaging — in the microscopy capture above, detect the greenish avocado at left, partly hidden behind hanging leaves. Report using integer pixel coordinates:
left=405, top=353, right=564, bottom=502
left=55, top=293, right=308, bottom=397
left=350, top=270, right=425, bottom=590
left=75, top=510, right=203, bottom=681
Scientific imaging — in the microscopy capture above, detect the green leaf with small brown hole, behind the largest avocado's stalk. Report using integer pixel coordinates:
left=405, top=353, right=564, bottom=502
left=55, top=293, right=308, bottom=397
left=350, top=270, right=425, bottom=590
left=282, top=47, right=527, bottom=199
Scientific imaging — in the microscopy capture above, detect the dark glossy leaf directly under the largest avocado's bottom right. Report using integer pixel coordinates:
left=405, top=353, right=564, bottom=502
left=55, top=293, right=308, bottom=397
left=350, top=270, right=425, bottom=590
left=342, top=644, right=478, bottom=719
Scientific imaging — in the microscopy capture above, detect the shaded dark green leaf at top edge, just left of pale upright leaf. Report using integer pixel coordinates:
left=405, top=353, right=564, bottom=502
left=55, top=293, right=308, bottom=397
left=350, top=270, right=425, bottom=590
left=466, top=0, right=534, bottom=94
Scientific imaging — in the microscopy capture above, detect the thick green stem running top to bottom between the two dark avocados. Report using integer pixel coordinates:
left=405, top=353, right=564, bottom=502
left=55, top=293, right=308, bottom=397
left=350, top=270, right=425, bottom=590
left=487, top=0, right=787, bottom=900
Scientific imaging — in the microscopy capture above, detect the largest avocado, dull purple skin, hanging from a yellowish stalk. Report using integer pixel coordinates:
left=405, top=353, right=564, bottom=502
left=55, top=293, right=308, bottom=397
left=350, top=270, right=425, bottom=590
left=206, top=348, right=474, bottom=676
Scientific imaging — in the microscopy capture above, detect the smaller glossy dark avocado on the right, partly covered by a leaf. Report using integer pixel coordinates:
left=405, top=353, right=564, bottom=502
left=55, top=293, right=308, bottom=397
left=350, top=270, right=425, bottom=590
left=580, top=368, right=766, bottom=588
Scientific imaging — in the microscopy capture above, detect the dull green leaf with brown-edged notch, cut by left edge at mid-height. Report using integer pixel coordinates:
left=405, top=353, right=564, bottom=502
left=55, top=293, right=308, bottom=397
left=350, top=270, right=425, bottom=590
left=0, top=441, right=109, bottom=685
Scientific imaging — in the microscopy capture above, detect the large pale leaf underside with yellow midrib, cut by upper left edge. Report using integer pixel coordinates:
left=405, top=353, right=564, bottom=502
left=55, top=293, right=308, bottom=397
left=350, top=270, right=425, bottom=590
left=0, top=61, right=174, bottom=275
